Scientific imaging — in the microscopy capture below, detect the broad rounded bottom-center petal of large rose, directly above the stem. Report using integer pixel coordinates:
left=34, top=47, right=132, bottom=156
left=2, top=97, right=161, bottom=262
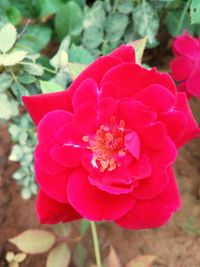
left=67, top=169, right=135, bottom=221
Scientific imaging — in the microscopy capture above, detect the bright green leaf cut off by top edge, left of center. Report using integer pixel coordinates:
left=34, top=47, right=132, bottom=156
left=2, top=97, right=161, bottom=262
left=37, top=0, right=63, bottom=17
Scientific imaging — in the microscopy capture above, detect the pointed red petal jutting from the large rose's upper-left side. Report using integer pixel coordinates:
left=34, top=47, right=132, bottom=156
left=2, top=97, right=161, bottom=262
left=22, top=91, right=72, bottom=125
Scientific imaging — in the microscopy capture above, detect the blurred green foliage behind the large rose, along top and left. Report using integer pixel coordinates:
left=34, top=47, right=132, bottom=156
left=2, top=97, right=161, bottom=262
left=0, top=0, right=200, bottom=199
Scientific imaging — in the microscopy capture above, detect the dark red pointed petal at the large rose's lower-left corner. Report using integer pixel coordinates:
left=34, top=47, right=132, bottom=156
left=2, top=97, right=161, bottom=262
left=36, top=190, right=81, bottom=224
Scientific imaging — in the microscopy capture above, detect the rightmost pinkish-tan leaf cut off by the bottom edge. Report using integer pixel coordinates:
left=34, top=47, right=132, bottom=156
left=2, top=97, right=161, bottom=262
left=126, top=255, right=156, bottom=267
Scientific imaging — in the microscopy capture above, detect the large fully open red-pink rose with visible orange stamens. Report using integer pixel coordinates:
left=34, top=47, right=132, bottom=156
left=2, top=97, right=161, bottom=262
left=23, top=45, right=200, bottom=229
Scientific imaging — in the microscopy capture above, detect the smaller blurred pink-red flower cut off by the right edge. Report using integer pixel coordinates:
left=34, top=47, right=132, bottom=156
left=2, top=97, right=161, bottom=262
left=170, top=31, right=200, bottom=98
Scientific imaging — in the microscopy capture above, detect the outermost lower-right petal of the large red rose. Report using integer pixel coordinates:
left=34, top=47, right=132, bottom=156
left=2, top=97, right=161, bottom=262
left=116, top=169, right=181, bottom=229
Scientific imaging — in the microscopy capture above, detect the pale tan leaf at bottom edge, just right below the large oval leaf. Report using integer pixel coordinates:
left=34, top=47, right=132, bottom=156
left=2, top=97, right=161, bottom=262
left=46, top=243, right=70, bottom=267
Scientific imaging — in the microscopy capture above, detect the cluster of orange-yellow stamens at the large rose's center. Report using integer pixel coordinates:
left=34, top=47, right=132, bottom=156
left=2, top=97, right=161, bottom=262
left=83, top=117, right=126, bottom=172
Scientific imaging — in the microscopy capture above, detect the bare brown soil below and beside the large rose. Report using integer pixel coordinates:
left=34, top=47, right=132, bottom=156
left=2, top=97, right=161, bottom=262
left=0, top=99, right=200, bottom=267
